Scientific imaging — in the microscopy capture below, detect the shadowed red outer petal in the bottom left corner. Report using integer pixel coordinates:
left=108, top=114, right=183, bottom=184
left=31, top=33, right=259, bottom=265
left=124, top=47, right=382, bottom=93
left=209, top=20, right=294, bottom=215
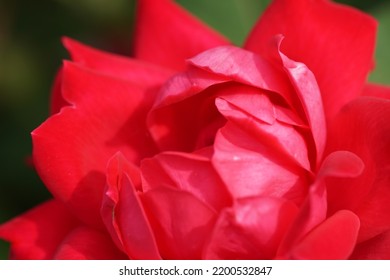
left=0, top=200, right=78, bottom=260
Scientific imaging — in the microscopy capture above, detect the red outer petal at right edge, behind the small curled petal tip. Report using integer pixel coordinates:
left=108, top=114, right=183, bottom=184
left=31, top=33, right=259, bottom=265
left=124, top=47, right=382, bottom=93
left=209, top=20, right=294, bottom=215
left=327, top=97, right=390, bottom=241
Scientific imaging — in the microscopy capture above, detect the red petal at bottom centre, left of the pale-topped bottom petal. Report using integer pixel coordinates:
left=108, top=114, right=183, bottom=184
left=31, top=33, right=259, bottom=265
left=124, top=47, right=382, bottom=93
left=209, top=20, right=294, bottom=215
left=141, top=187, right=216, bottom=260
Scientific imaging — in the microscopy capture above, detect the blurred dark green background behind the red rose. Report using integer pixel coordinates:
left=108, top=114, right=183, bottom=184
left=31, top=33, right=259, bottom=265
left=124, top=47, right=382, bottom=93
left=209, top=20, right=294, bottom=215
left=0, top=0, right=390, bottom=259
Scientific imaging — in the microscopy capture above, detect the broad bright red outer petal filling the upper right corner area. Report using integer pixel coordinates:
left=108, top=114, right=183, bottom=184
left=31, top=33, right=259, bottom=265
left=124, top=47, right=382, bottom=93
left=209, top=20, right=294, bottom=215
left=245, top=0, right=376, bottom=119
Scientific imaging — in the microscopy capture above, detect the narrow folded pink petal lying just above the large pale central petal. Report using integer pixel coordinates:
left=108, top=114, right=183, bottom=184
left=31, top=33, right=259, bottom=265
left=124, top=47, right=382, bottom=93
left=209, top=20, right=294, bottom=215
left=216, top=86, right=310, bottom=170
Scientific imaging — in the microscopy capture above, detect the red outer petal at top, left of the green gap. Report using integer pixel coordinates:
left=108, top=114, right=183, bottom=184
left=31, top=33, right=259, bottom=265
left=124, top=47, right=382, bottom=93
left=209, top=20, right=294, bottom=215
left=135, top=0, right=229, bottom=70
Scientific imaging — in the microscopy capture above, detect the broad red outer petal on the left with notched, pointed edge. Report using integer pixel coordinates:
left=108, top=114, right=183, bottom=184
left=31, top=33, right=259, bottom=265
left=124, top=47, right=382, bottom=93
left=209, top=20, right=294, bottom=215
left=32, top=63, right=156, bottom=229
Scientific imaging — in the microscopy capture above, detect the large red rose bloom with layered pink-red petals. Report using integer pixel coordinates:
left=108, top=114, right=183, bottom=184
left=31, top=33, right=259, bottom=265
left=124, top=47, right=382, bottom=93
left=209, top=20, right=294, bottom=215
left=0, top=0, right=390, bottom=259
